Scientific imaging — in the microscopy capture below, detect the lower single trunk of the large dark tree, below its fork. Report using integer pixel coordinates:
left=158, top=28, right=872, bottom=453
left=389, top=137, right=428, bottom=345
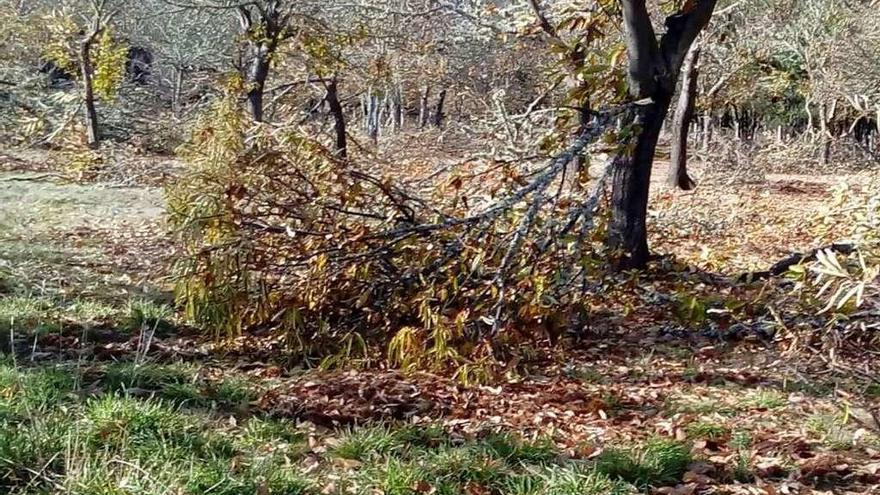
left=609, top=91, right=672, bottom=270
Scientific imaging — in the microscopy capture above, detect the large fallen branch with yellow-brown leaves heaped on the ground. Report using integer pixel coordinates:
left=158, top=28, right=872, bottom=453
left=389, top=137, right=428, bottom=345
left=168, top=84, right=620, bottom=376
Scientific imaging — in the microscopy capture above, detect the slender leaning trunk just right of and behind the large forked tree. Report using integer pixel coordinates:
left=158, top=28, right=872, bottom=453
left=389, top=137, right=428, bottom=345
left=667, top=45, right=700, bottom=191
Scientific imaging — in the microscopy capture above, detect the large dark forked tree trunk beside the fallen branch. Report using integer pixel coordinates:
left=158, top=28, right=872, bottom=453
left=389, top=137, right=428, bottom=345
left=608, top=0, right=717, bottom=269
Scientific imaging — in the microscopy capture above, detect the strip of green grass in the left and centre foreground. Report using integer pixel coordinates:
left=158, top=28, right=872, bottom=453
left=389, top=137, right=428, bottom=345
left=0, top=359, right=708, bottom=495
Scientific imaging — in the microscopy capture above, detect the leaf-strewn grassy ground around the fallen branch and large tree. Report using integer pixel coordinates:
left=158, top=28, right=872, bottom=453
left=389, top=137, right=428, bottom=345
left=0, top=149, right=880, bottom=495
